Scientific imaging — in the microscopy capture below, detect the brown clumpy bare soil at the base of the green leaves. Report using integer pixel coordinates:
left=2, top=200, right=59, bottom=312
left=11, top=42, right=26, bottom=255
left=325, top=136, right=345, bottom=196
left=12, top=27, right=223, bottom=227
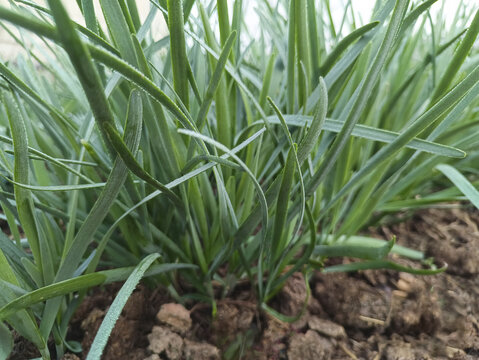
left=6, top=208, right=479, bottom=360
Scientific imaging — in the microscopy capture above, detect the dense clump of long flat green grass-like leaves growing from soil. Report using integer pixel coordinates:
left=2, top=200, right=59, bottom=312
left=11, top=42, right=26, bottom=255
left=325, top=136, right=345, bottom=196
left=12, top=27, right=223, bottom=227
left=0, top=0, right=479, bottom=359
